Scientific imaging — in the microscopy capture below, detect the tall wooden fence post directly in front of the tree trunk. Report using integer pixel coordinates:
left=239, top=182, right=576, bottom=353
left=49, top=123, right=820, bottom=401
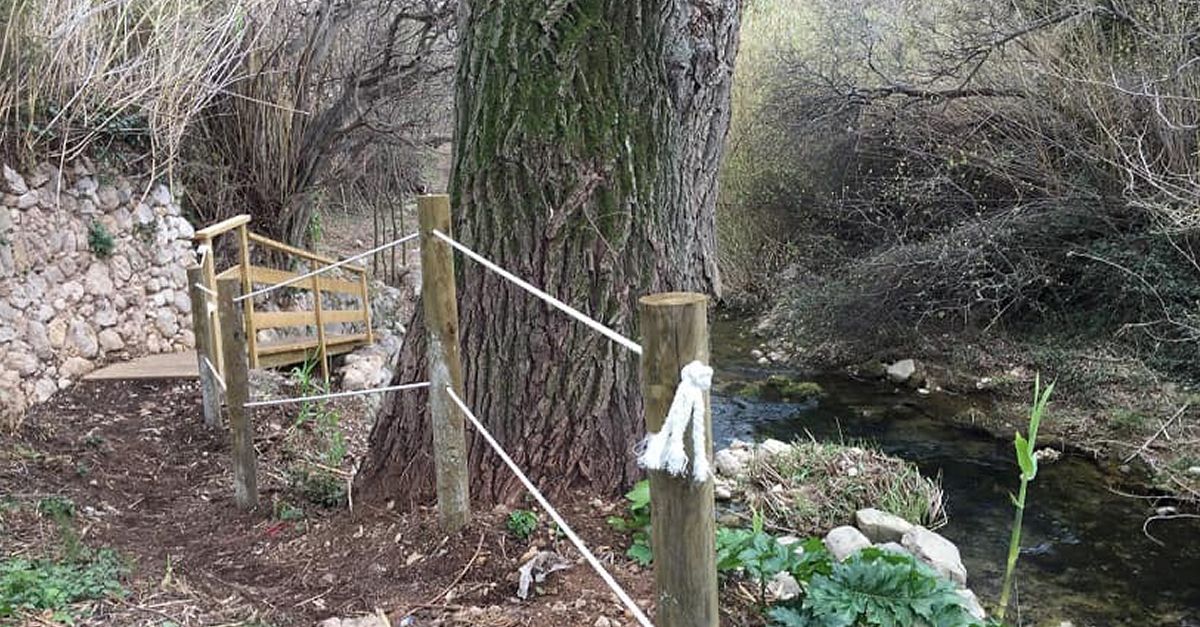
left=416, top=195, right=470, bottom=531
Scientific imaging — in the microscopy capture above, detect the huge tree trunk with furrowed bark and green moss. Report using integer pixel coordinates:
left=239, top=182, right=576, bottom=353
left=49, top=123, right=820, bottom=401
left=360, top=0, right=740, bottom=504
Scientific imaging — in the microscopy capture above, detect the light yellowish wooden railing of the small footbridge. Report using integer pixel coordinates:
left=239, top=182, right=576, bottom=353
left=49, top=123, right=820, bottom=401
left=192, top=215, right=374, bottom=386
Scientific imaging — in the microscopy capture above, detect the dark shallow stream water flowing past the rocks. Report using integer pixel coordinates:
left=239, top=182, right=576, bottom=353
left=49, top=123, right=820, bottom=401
left=713, top=321, right=1200, bottom=627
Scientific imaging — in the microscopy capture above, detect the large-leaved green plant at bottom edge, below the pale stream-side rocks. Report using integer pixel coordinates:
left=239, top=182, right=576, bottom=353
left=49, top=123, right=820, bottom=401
left=768, top=548, right=982, bottom=627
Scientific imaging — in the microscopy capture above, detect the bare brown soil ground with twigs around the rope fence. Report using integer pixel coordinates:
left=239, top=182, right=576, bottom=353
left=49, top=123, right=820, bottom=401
left=0, top=381, right=757, bottom=626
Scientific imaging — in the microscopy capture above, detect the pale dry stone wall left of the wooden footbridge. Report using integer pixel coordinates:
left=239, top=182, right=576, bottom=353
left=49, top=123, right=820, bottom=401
left=0, top=160, right=196, bottom=425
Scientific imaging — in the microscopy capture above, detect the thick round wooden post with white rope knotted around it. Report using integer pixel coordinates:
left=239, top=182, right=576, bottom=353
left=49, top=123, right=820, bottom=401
left=638, top=293, right=720, bottom=627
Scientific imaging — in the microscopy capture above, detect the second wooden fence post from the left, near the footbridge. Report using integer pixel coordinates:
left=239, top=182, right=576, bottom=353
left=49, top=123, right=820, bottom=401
left=217, top=277, right=258, bottom=509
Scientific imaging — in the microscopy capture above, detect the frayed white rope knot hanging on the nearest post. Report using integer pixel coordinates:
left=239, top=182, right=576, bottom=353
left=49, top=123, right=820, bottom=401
left=637, top=362, right=713, bottom=483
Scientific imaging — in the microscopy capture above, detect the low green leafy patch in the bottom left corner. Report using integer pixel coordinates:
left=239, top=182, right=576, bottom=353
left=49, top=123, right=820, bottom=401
left=0, top=549, right=125, bottom=622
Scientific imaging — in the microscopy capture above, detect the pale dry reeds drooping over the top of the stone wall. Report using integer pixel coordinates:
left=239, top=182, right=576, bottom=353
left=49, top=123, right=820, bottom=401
left=0, top=0, right=246, bottom=169
